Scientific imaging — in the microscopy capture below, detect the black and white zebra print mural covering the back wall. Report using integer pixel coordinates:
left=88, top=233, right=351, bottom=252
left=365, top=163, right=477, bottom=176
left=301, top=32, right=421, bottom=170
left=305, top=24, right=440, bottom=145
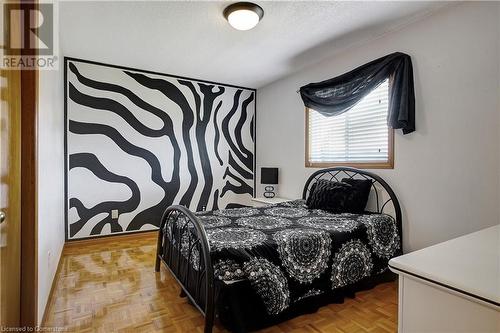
left=64, top=58, right=256, bottom=240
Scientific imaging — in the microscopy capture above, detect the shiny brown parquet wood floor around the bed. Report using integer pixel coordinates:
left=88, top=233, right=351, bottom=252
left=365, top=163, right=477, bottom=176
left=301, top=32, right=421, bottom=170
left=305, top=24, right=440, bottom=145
left=43, top=233, right=397, bottom=333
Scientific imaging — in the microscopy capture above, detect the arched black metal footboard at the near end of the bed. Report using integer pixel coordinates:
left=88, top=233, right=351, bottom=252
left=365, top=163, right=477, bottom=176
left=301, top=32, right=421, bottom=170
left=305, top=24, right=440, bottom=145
left=155, top=206, right=215, bottom=333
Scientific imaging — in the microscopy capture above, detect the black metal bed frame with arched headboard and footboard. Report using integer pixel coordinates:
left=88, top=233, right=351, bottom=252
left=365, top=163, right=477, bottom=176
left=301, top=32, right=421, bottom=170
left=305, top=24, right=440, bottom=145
left=155, top=167, right=402, bottom=333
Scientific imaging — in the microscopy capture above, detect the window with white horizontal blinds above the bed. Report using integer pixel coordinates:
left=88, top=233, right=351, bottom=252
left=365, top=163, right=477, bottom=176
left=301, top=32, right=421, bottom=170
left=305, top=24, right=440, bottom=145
left=306, top=80, right=394, bottom=168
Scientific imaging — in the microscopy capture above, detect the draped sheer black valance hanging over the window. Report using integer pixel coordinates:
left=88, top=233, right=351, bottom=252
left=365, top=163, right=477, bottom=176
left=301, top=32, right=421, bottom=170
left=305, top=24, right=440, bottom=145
left=300, top=52, right=415, bottom=134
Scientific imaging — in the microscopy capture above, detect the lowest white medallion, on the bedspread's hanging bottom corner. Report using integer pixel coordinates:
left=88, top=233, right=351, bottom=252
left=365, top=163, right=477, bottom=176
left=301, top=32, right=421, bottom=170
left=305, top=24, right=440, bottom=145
left=243, top=258, right=290, bottom=315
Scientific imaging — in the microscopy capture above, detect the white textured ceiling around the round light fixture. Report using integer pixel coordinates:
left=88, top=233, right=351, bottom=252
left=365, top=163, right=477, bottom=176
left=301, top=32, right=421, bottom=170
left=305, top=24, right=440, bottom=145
left=59, top=1, right=452, bottom=88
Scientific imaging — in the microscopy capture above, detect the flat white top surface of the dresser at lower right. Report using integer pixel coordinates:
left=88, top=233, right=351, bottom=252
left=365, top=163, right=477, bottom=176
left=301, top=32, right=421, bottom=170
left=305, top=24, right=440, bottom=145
left=389, top=224, right=500, bottom=306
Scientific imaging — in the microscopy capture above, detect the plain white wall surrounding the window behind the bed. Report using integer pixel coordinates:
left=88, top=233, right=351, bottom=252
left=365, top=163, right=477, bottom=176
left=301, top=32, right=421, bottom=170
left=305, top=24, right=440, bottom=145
left=257, top=3, right=500, bottom=251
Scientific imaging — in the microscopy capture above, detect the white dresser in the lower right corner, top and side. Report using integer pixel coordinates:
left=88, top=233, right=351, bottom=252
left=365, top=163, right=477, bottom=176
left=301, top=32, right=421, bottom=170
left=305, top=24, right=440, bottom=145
left=389, top=225, right=500, bottom=333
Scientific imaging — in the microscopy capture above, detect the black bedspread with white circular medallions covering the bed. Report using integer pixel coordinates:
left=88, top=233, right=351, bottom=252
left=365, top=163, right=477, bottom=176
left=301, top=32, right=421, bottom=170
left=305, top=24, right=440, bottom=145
left=178, top=200, right=401, bottom=315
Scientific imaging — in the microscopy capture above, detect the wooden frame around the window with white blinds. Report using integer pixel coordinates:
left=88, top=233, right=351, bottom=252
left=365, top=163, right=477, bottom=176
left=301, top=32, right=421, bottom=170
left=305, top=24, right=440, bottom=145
left=304, top=107, right=394, bottom=169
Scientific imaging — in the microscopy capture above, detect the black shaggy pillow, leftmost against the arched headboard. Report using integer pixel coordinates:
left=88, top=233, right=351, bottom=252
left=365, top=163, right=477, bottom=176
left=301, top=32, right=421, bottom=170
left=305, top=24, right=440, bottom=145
left=307, top=179, right=356, bottom=213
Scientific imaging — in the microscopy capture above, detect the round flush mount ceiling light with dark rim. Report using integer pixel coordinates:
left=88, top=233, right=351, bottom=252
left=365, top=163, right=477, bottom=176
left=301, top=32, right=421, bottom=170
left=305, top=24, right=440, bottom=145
left=224, top=2, right=264, bottom=30
